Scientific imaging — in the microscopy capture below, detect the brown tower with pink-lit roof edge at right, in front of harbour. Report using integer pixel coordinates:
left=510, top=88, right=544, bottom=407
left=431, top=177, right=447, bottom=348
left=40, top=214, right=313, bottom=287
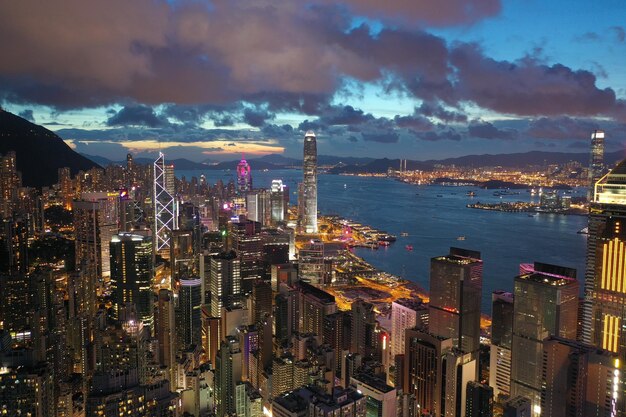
left=511, top=262, right=578, bottom=417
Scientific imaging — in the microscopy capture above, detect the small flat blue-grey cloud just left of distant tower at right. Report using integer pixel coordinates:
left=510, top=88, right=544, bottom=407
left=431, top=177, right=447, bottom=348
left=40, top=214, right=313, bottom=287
left=526, top=117, right=599, bottom=140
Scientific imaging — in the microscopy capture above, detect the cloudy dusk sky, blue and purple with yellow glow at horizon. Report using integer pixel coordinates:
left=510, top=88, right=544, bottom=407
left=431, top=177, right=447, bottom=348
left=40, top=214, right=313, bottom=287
left=0, top=0, right=626, bottom=161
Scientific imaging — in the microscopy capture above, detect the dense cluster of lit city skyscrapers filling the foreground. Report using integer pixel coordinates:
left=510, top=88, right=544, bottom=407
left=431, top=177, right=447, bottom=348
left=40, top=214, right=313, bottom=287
left=0, top=127, right=626, bottom=417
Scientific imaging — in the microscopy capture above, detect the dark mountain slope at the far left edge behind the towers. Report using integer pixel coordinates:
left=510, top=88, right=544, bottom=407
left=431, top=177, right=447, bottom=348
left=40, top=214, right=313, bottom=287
left=0, top=108, right=99, bottom=187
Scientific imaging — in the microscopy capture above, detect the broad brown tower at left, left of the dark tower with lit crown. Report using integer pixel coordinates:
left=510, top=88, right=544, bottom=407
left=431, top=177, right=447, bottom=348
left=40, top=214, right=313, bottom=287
left=72, top=193, right=118, bottom=291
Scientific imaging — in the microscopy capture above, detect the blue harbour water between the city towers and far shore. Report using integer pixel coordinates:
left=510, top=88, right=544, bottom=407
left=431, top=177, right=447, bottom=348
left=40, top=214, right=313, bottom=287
left=177, top=167, right=587, bottom=313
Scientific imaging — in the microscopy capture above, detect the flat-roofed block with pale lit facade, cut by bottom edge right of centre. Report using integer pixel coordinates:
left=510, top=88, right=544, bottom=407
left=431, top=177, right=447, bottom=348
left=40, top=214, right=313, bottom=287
left=350, top=373, right=398, bottom=417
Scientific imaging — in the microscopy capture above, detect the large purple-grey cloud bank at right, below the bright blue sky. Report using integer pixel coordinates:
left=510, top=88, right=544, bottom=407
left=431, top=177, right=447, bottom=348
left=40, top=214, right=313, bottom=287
left=451, top=45, right=615, bottom=116
